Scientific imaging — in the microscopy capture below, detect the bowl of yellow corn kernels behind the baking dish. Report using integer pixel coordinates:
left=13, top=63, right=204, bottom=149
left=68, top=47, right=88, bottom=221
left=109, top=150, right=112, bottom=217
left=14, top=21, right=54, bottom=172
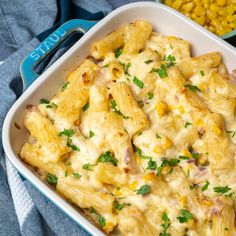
left=156, top=0, right=236, bottom=39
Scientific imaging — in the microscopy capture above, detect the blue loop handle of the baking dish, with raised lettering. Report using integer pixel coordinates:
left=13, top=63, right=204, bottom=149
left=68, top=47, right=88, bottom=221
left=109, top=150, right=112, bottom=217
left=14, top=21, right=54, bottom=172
left=20, top=19, right=97, bottom=90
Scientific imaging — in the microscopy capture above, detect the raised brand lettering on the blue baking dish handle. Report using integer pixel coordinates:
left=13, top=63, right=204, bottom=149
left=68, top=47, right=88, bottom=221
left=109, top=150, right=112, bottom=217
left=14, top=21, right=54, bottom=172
left=30, top=28, right=67, bottom=61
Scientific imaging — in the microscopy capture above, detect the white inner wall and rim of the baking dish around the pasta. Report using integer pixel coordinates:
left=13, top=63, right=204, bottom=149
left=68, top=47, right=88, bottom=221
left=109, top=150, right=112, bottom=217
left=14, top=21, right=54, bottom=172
left=2, top=2, right=236, bottom=235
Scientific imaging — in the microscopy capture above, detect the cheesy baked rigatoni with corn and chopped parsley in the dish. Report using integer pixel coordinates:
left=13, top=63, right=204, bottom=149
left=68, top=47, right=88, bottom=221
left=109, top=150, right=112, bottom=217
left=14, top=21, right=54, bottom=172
left=20, top=19, right=236, bottom=236
